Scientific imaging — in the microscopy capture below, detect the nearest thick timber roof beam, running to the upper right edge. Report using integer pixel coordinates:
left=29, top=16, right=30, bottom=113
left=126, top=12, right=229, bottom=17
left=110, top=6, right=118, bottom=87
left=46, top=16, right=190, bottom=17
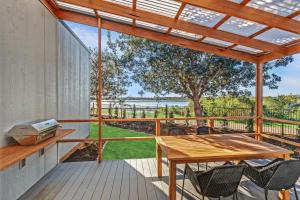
left=179, top=0, right=300, bottom=34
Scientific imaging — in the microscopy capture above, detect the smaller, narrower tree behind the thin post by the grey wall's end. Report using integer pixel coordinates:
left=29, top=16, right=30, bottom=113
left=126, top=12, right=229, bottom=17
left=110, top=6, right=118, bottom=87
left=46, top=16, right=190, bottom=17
left=90, top=32, right=131, bottom=109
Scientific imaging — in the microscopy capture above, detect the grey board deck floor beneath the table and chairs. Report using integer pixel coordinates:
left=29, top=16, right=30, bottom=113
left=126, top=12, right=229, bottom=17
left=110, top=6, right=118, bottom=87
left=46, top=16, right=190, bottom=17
left=20, top=158, right=299, bottom=200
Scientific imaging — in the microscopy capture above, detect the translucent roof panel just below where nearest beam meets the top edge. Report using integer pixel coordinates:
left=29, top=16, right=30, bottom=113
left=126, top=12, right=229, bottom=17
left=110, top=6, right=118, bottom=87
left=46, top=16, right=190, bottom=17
left=179, top=4, right=225, bottom=27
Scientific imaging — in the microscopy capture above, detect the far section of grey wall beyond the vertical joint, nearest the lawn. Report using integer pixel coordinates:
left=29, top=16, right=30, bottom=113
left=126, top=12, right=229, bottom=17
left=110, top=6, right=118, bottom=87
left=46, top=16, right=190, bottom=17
left=58, top=23, right=89, bottom=155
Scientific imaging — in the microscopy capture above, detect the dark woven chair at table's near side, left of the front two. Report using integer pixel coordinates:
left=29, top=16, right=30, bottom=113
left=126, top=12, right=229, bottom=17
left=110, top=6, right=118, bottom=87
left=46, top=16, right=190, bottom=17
left=181, top=164, right=246, bottom=199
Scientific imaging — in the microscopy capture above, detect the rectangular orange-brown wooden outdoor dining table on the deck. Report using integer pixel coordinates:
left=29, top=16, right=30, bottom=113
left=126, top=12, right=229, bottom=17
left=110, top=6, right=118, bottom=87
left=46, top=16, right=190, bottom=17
left=156, top=134, right=293, bottom=200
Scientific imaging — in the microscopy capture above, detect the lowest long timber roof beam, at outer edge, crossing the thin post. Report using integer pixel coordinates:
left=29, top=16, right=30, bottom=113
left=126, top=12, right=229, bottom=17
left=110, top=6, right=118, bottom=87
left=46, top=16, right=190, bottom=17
left=56, top=10, right=258, bottom=63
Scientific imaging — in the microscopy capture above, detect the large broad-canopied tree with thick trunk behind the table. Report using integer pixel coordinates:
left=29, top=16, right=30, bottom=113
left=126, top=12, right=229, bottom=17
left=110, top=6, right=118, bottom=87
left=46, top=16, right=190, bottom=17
left=116, top=35, right=293, bottom=125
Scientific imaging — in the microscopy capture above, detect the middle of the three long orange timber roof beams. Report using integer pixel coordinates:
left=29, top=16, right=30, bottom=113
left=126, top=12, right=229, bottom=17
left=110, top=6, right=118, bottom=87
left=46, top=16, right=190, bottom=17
left=61, top=0, right=286, bottom=56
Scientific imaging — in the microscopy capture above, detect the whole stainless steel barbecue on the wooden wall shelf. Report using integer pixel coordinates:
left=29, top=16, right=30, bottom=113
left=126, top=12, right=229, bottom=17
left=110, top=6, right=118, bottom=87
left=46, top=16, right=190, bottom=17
left=7, top=119, right=59, bottom=145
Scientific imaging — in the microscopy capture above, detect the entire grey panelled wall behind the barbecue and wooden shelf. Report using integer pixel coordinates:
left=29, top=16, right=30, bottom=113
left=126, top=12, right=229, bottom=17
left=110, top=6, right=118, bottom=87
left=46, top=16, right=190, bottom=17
left=0, top=0, right=89, bottom=200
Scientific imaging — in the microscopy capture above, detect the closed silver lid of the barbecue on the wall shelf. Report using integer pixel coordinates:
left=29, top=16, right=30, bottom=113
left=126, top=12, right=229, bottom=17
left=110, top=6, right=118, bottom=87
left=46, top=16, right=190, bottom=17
left=7, top=119, right=59, bottom=136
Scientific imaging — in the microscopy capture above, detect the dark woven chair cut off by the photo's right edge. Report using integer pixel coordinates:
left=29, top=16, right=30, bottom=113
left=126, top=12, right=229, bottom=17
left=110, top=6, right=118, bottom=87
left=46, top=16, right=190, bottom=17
left=241, top=159, right=300, bottom=200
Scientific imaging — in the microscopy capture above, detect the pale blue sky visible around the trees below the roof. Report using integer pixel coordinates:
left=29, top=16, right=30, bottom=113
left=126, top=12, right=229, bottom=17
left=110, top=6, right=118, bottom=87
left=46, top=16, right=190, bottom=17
left=66, top=22, right=300, bottom=97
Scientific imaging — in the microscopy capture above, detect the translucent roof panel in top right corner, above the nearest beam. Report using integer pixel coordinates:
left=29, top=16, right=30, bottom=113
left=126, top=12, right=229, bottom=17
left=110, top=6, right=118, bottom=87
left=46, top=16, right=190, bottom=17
left=247, top=0, right=300, bottom=16
